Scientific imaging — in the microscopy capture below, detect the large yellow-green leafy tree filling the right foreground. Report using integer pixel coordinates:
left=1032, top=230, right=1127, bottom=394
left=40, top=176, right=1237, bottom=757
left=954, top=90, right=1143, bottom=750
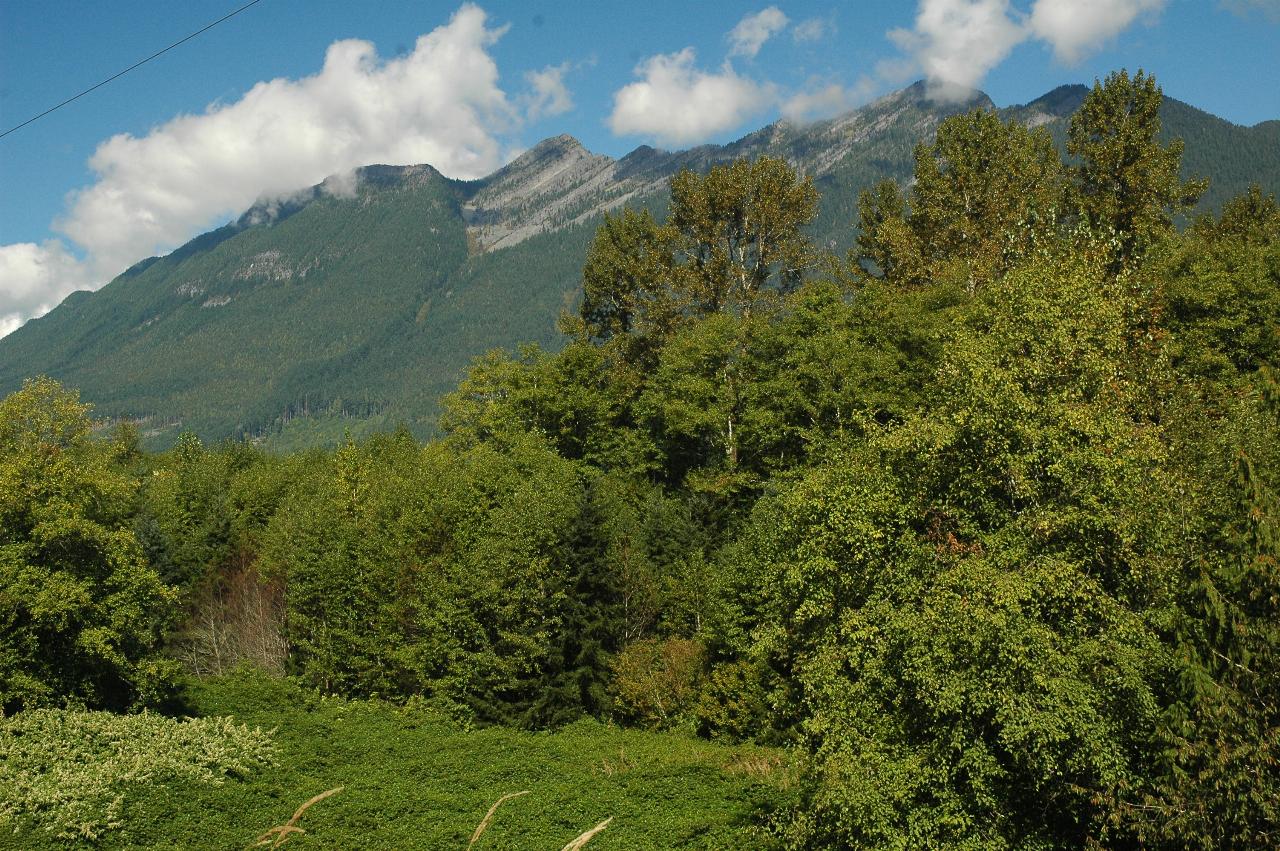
left=731, top=257, right=1192, bottom=848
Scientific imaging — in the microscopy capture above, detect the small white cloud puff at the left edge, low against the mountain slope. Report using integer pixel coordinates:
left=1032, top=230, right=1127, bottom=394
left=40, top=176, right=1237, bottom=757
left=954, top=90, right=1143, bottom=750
left=0, top=239, right=90, bottom=337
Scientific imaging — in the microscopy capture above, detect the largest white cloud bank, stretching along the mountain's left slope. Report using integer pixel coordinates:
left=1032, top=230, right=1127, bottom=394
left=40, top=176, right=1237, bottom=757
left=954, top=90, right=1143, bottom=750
left=0, top=3, right=532, bottom=335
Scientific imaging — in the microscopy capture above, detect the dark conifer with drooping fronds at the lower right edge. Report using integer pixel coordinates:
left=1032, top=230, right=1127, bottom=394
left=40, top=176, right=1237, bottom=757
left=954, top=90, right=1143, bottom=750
left=1146, top=369, right=1280, bottom=848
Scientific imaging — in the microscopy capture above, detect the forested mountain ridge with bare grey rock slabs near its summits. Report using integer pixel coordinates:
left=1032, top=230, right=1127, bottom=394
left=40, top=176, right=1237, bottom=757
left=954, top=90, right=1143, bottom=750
left=0, top=83, right=1280, bottom=447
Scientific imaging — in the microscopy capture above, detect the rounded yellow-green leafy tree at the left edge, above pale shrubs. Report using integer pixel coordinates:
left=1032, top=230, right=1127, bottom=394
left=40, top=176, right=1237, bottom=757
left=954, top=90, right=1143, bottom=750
left=0, top=379, right=175, bottom=712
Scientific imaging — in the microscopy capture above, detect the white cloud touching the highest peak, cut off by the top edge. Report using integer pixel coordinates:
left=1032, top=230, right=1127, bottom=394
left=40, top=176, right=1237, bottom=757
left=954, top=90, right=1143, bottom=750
left=888, top=0, right=1025, bottom=100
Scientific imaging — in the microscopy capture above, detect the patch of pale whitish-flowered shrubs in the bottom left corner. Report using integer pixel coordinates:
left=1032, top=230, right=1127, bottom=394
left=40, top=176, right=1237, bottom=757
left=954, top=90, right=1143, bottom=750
left=0, top=709, right=276, bottom=843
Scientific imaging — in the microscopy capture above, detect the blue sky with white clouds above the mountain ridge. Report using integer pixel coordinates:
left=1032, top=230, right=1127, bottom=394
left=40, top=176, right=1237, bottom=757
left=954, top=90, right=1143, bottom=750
left=0, top=0, right=1280, bottom=337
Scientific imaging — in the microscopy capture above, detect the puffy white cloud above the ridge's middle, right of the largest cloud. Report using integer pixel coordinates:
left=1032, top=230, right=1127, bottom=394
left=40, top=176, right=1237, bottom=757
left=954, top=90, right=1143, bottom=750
left=608, top=47, right=778, bottom=145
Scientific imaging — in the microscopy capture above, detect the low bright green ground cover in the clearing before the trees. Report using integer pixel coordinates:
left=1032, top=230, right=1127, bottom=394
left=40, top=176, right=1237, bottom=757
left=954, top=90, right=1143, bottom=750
left=0, top=674, right=791, bottom=851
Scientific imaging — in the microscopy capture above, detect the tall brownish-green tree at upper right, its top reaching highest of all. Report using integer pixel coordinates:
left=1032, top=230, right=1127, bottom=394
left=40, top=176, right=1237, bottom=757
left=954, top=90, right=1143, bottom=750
left=1066, top=70, right=1208, bottom=267
